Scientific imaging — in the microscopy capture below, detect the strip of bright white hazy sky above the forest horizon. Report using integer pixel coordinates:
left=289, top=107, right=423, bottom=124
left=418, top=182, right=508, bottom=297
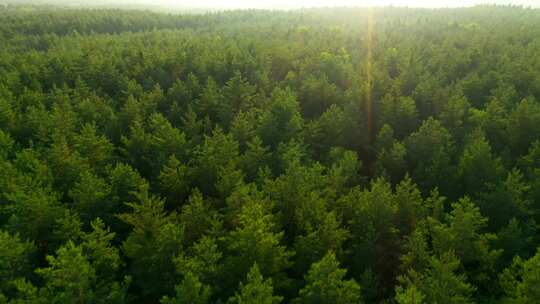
left=167, top=0, right=540, bottom=8
